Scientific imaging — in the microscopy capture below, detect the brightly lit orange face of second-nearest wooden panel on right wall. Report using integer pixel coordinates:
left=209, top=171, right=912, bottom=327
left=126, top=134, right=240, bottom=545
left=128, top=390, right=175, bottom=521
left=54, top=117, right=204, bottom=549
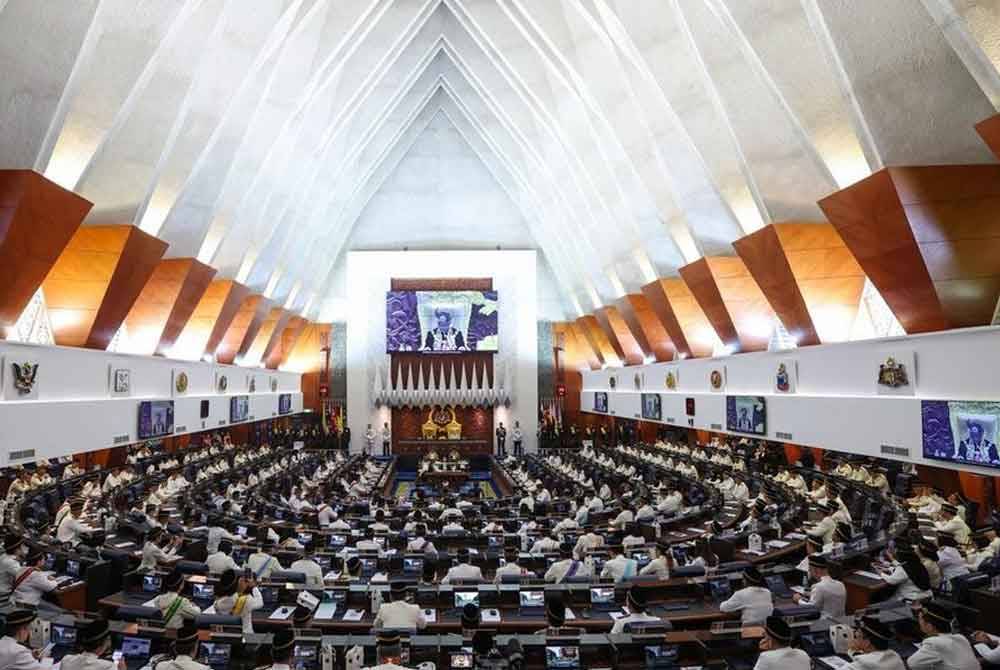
left=774, top=222, right=865, bottom=342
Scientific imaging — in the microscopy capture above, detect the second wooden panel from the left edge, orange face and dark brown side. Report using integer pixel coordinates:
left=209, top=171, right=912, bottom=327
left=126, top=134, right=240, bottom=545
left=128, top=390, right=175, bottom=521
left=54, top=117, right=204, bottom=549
left=42, top=226, right=167, bottom=349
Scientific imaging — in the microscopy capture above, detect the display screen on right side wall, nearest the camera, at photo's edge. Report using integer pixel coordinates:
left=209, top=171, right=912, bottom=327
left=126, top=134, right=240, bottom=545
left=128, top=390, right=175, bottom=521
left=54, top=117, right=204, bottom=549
left=920, top=400, right=1000, bottom=468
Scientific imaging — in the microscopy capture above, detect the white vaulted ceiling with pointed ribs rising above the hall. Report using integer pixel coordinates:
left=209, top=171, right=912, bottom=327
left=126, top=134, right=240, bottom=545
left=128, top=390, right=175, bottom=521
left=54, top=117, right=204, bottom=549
left=0, top=0, right=1000, bottom=318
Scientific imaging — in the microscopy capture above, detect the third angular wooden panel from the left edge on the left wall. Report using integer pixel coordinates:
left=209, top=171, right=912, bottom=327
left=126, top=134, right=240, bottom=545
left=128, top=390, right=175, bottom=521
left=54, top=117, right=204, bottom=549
left=125, top=258, right=215, bottom=356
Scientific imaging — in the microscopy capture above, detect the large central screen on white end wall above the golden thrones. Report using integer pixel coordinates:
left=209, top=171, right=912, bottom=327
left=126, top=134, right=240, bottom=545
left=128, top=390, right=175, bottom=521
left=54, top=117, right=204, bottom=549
left=385, top=291, right=499, bottom=354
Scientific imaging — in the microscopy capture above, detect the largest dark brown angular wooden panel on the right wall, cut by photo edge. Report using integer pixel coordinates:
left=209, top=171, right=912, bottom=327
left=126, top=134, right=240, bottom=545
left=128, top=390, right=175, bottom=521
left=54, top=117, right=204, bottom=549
left=820, top=165, right=1000, bottom=333
